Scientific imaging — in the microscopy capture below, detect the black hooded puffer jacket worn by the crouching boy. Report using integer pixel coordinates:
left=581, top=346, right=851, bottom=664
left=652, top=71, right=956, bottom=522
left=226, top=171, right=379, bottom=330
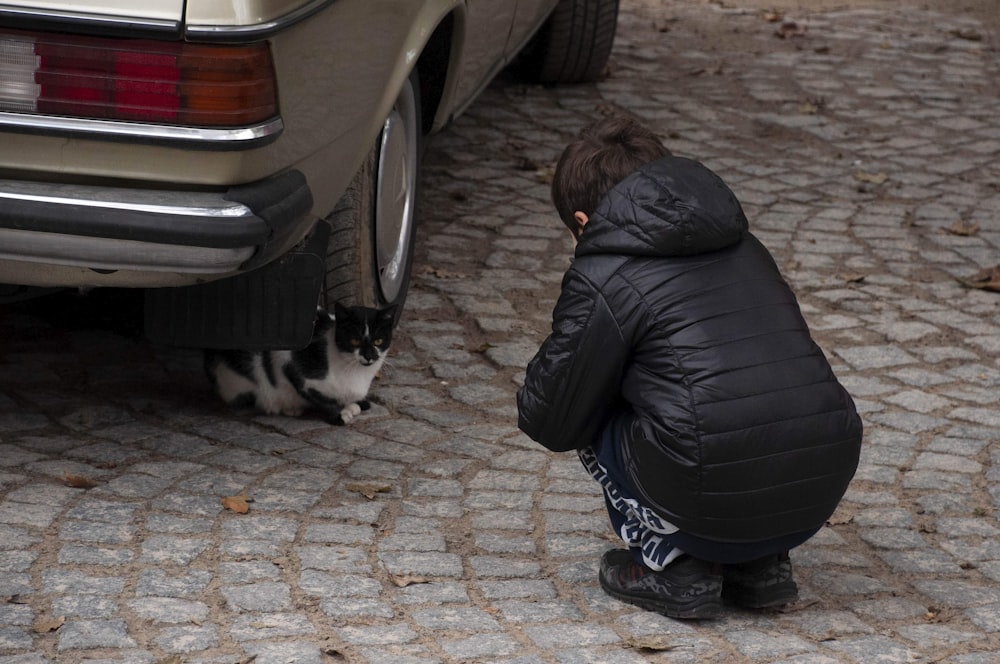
left=518, top=157, right=861, bottom=542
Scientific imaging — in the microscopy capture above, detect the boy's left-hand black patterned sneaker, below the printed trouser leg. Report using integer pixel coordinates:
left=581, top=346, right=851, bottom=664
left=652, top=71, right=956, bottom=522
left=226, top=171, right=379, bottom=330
left=599, top=549, right=722, bottom=618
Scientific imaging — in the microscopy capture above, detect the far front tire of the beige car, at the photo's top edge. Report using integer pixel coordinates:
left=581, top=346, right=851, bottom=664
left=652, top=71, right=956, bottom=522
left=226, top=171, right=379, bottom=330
left=516, top=0, right=618, bottom=83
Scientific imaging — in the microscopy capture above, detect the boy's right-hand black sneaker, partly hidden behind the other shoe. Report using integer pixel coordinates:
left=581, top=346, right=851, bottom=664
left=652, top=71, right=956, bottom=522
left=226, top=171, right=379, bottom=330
left=722, top=553, right=799, bottom=609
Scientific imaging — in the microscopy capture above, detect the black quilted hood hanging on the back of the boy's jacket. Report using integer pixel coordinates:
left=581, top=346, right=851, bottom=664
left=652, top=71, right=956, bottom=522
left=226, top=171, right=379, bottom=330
left=576, top=156, right=748, bottom=256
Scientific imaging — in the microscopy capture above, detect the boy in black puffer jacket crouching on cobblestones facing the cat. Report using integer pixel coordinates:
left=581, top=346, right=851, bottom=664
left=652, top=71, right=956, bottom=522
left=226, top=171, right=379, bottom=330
left=517, top=117, right=862, bottom=618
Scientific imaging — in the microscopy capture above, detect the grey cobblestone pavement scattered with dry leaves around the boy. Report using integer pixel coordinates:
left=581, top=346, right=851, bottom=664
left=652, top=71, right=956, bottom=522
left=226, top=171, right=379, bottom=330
left=0, top=0, right=1000, bottom=664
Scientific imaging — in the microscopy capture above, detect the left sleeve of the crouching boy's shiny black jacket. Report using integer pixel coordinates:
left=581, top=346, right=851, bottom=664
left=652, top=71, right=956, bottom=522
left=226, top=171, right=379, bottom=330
left=517, top=273, right=629, bottom=452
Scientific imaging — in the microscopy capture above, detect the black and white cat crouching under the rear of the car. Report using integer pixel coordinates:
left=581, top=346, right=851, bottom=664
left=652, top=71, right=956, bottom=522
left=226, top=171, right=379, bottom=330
left=205, top=303, right=396, bottom=424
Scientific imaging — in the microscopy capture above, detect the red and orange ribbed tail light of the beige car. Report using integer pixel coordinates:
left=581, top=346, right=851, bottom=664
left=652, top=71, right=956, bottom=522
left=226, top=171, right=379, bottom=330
left=0, top=32, right=278, bottom=127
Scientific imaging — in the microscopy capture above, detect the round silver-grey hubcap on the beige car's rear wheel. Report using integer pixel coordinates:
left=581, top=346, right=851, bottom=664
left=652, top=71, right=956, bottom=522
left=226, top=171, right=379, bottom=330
left=375, top=80, right=418, bottom=302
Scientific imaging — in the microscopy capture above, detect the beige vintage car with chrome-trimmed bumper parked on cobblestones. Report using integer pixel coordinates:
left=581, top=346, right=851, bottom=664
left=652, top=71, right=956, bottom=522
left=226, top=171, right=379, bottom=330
left=0, top=0, right=618, bottom=348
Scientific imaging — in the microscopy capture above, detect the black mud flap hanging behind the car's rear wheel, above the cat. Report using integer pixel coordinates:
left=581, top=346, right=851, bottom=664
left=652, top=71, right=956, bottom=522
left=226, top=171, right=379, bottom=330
left=145, top=222, right=330, bottom=350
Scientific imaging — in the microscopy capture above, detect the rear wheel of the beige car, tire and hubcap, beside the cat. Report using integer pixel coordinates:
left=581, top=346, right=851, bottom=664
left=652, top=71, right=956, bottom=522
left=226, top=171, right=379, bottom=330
left=320, top=70, right=423, bottom=320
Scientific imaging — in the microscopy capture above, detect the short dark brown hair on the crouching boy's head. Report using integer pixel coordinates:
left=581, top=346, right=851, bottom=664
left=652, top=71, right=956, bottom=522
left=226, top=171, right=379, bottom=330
left=552, top=115, right=670, bottom=235
